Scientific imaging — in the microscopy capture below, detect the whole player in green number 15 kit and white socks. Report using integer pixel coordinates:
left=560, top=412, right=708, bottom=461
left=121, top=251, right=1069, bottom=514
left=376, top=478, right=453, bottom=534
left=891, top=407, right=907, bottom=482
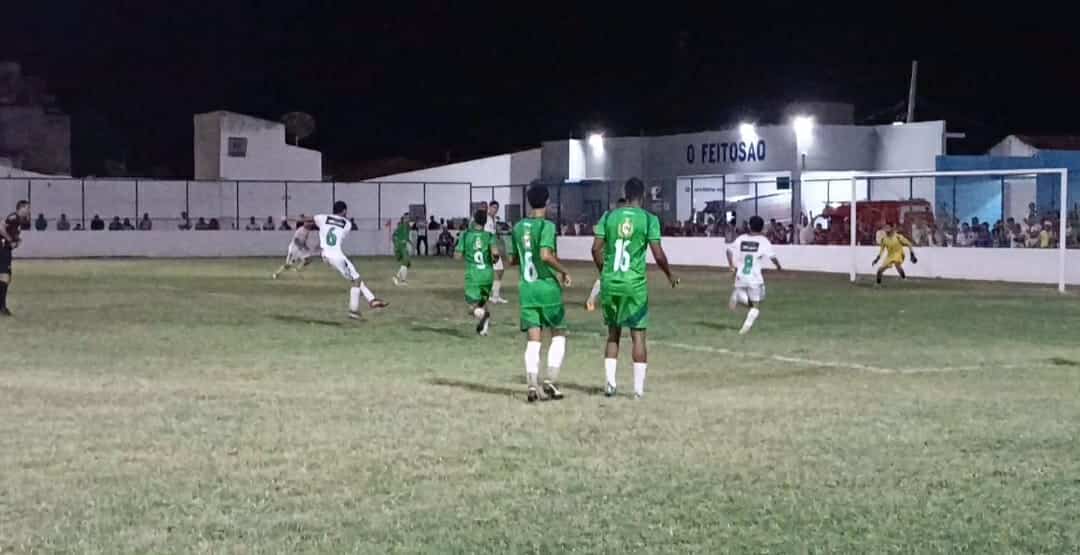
left=593, top=177, right=678, bottom=398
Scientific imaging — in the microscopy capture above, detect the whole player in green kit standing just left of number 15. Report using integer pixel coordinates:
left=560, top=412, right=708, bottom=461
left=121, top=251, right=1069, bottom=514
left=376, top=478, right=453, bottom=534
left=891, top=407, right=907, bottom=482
left=511, top=185, right=571, bottom=403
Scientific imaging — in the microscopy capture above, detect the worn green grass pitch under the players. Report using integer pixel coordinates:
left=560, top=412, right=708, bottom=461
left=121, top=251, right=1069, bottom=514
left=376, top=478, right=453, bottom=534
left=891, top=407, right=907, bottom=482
left=0, top=259, right=1080, bottom=554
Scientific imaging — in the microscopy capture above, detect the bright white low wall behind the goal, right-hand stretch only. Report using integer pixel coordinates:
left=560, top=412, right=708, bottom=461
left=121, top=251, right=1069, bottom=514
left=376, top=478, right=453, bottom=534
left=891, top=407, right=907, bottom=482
left=558, top=238, right=1080, bottom=285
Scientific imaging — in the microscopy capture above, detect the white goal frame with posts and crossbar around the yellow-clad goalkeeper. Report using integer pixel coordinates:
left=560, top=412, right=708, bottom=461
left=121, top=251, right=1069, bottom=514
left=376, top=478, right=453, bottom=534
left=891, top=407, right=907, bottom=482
left=849, top=167, right=1069, bottom=293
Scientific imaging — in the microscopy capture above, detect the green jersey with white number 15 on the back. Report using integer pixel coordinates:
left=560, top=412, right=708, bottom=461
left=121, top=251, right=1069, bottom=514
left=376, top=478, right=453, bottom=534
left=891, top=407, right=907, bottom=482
left=594, top=206, right=660, bottom=295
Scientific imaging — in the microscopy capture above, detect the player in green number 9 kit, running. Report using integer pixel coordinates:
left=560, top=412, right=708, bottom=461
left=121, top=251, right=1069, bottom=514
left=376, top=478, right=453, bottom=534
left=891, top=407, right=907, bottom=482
left=454, top=209, right=501, bottom=336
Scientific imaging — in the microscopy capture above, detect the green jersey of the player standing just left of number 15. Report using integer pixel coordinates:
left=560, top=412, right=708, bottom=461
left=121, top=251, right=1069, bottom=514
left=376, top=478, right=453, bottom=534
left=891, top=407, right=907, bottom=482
left=511, top=218, right=563, bottom=308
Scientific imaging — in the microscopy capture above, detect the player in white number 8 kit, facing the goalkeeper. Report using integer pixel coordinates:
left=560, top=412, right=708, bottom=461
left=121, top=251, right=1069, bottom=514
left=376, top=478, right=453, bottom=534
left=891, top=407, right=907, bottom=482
left=727, top=216, right=782, bottom=335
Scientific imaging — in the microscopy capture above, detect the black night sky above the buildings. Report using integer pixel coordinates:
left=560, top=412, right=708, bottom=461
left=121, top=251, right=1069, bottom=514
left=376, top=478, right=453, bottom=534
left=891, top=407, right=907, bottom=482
left=0, top=1, right=1080, bottom=177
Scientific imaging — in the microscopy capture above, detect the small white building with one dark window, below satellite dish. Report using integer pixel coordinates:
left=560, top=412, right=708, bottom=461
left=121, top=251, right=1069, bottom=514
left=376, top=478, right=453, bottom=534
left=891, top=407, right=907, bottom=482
left=194, top=110, right=323, bottom=181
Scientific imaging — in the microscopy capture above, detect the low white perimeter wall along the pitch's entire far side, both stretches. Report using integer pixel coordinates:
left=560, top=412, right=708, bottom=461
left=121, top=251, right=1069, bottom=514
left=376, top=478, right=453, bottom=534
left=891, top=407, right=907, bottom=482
left=15, top=233, right=1080, bottom=285
